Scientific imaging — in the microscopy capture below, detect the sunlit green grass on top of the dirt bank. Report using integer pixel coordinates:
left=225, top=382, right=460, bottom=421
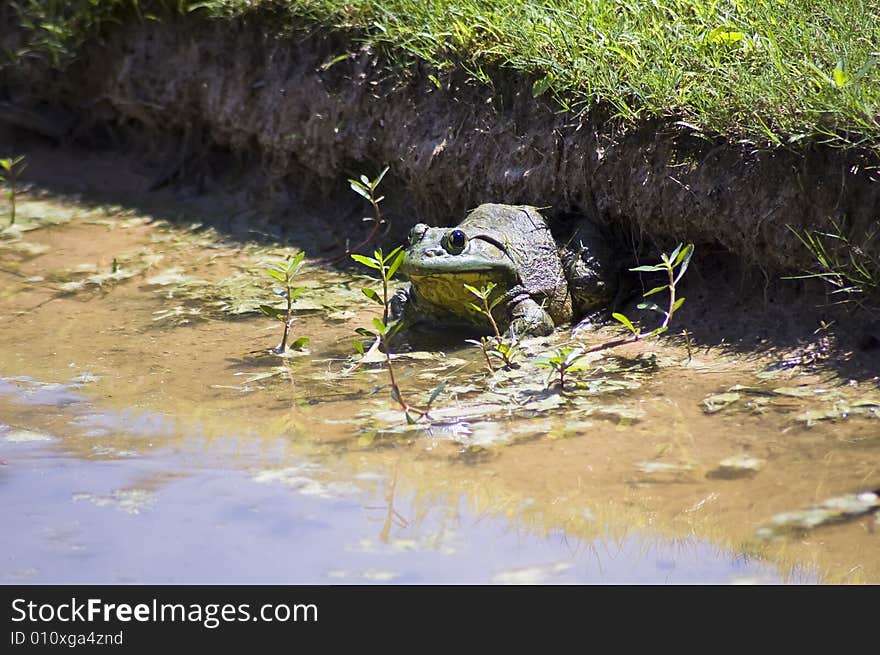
left=5, top=0, right=880, bottom=152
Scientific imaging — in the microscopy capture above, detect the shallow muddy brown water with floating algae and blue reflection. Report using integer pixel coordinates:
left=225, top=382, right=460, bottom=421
left=0, top=190, right=880, bottom=583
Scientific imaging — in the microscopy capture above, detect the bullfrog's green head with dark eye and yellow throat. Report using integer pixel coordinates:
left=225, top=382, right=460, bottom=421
left=400, top=223, right=519, bottom=317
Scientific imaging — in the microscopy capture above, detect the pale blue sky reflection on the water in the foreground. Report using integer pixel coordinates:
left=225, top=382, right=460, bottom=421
left=0, top=410, right=814, bottom=584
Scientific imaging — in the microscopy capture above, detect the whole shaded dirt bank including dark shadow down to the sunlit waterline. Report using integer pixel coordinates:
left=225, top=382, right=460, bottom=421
left=0, top=10, right=880, bottom=377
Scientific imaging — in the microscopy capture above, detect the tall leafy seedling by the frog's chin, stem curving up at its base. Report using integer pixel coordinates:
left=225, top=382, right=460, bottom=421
left=351, top=246, right=446, bottom=424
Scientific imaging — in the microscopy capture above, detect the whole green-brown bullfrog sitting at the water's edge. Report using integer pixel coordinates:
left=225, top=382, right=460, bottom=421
left=392, top=204, right=610, bottom=336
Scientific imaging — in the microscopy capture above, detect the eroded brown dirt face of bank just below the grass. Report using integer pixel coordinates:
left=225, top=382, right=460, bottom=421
left=0, top=10, right=880, bottom=356
